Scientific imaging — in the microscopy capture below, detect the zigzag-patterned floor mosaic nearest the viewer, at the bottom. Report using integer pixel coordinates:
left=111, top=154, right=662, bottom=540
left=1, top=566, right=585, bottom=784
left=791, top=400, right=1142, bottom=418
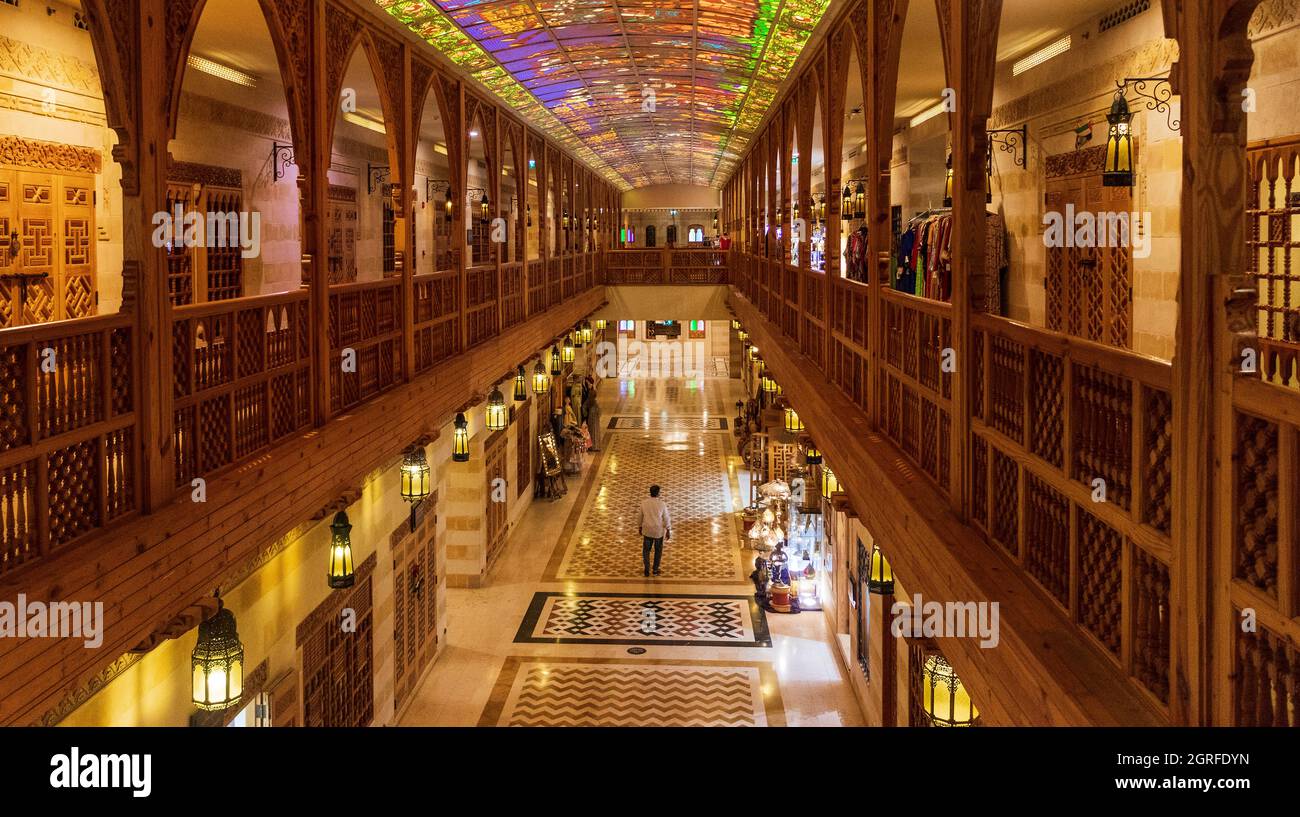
left=478, top=656, right=785, bottom=726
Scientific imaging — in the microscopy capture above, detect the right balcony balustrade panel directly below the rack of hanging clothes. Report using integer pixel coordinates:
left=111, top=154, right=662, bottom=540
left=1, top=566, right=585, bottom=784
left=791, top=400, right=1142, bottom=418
left=878, top=290, right=953, bottom=493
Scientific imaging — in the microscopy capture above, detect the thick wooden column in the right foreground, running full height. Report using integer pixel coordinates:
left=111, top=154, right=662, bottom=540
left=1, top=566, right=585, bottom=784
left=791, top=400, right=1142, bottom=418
left=1164, top=0, right=1258, bottom=725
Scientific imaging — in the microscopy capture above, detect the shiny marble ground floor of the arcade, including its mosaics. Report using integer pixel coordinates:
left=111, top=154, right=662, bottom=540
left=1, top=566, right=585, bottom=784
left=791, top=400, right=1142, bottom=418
left=402, top=377, right=862, bottom=726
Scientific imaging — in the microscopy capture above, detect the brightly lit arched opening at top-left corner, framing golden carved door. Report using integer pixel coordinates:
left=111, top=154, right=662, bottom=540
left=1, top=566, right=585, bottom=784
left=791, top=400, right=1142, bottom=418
left=0, top=4, right=122, bottom=328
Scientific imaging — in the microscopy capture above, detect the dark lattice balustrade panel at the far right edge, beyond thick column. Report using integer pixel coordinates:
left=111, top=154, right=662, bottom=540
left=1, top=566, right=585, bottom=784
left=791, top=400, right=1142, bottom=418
left=1216, top=376, right=1300, bottom=726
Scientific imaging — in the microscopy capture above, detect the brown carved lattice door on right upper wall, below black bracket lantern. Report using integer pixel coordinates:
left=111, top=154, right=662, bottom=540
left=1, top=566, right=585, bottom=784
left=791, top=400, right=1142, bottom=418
left=1044, top=146, right=1139, bottom=347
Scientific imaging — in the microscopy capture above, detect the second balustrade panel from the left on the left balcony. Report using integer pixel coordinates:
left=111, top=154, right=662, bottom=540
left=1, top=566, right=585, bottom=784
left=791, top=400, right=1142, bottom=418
left=172, top=290, right=312, bottom=488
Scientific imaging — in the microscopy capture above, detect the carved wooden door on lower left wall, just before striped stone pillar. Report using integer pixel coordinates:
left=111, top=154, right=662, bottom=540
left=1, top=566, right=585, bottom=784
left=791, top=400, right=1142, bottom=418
left=393, top=494, right=438, bottom=710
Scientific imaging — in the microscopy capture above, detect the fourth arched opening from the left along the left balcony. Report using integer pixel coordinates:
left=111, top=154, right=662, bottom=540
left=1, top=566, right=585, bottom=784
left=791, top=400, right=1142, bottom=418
left=413, top=86, right=458, bottom=273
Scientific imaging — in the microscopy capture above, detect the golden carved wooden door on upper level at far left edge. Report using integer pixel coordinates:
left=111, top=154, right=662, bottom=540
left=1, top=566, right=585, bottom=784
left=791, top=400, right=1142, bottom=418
left=0, top=168, right=96, bottom=328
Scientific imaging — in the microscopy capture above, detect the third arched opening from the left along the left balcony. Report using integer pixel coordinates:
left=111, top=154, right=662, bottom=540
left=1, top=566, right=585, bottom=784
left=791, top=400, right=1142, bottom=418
left=325, top=36, right=404, bottom=284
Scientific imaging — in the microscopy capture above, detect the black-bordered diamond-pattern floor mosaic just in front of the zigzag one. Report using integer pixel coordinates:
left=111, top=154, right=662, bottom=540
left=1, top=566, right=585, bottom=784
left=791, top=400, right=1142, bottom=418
left=515, top=592, right=772, bottom=647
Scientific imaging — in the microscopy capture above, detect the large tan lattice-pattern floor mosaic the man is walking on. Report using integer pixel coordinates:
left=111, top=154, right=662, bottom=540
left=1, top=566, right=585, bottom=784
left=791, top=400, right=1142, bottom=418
left=547, top=432, right=746, bottom=584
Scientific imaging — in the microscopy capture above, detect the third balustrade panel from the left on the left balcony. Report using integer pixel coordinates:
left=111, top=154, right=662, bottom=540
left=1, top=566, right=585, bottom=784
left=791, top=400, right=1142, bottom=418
left=329, top=278, right=402, bottom=414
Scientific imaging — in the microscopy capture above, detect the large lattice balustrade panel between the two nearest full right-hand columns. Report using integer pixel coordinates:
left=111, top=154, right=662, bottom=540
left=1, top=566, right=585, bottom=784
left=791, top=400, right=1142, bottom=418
left=970, top=315, right=1175, bottom=706
